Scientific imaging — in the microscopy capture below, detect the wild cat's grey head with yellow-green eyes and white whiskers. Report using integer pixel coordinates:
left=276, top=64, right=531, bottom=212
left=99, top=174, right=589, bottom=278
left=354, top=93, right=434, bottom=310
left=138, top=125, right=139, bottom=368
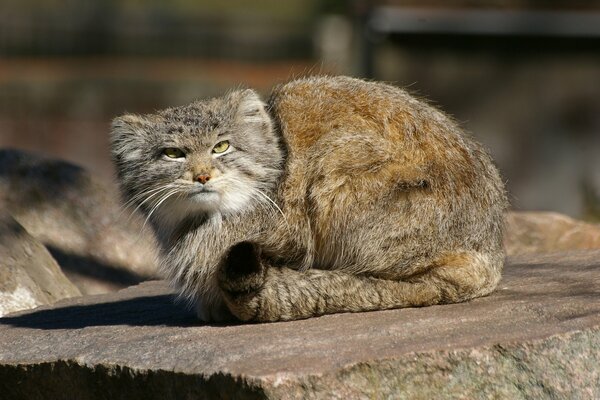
left=111, top=90, right=283, bottom=230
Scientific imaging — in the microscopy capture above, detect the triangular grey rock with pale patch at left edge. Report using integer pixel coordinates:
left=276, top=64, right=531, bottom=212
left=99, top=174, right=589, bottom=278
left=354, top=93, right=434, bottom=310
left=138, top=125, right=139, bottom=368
left=0, top=210, right=81, bottom=317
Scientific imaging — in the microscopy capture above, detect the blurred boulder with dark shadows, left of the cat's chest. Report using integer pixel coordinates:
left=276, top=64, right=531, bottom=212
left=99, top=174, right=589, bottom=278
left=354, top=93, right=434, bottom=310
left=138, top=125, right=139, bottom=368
left=0, top=150, right=156, bottom=293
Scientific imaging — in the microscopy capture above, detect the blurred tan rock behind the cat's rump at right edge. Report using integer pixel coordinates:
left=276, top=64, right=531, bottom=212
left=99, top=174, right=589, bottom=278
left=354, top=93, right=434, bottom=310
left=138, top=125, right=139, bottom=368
left=504, top=211, right=600, bottom=255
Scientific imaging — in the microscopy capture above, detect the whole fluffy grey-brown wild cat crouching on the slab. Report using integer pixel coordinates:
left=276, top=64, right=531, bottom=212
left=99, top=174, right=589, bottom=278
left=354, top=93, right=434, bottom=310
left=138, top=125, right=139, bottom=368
left=111, top=76, right=507, bottom=321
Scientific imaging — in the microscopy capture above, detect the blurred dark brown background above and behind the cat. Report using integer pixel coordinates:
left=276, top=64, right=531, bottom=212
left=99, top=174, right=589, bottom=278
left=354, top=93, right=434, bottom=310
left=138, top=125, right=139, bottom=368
left=0, top=0, right=600, bottom=220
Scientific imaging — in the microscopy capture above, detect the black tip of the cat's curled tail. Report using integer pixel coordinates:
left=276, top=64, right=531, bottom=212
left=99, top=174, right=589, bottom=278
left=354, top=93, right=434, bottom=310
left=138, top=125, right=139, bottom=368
left=218, top=242, right=264, bottom=297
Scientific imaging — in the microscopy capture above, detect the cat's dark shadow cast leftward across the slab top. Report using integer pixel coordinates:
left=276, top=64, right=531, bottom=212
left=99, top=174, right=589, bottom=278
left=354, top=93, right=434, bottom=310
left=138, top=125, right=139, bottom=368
left=0, top=294, right=201, bottom=329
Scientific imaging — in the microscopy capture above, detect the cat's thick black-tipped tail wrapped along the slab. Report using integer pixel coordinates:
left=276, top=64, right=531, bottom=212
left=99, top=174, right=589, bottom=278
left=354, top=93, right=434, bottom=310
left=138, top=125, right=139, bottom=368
left=218, top=242, right=500, bottom=322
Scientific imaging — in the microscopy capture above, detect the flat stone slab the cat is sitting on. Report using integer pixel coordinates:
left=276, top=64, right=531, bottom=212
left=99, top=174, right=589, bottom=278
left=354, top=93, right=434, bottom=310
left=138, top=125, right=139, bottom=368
left=0, top=251, right=600, bottom=400
